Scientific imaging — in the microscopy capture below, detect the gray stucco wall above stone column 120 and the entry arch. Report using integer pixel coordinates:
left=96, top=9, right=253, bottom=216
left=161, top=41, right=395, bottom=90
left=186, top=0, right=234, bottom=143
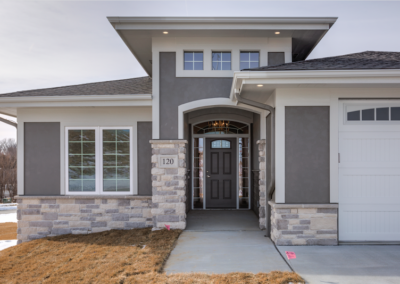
left=160, top=52, right=232, bottom=139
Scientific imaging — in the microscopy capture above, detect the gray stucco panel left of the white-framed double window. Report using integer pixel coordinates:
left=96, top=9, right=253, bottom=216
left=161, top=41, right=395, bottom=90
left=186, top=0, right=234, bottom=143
left=24, top=122, right=60, bottom=195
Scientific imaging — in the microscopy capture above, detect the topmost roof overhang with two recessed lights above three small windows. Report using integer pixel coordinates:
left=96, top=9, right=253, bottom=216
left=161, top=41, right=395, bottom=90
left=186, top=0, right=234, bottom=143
left=108, top=17, right=337, bottom=76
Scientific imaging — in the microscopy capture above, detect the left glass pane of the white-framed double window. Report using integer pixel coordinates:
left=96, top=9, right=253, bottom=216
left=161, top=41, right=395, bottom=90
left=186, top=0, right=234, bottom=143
left=68, top=129, right=96, bottom=191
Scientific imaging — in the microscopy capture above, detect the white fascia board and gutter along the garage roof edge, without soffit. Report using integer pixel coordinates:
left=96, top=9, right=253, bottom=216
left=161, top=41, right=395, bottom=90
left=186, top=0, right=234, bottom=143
left=230, top=69, right=400, bottom=101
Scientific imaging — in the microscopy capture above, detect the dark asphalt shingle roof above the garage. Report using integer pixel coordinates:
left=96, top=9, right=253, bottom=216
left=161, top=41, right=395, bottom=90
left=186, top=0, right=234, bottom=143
left=242, top=51, right=400, bottom=71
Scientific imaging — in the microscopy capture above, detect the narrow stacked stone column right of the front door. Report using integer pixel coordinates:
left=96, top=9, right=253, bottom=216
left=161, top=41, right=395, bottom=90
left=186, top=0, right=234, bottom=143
left=257, top=139, right=267, bottom=230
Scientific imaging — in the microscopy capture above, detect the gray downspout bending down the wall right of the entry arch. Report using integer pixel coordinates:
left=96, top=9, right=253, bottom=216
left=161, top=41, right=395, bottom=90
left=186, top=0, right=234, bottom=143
left=236, top=93, right=275, bottom=235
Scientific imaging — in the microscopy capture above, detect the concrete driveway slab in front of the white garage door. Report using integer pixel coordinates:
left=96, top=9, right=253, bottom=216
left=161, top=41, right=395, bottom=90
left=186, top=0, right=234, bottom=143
left=278, top=245, right=400, bottom=284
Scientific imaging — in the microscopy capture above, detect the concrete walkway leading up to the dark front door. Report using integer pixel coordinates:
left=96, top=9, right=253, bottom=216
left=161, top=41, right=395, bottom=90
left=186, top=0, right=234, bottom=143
left=164, top=210, right=290, bottom=274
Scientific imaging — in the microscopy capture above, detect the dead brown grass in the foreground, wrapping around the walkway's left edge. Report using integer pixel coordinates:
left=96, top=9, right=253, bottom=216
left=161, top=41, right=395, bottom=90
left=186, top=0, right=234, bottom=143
left=0, top=229, right=303, bottom=284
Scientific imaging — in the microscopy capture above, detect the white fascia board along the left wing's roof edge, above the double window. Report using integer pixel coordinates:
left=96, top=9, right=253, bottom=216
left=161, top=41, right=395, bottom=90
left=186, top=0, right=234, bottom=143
left=0, top=94, right=152, bottom=108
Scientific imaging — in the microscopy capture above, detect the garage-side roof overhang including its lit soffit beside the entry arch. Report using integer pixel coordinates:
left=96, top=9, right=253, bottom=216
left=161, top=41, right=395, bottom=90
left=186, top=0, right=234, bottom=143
left=230, top=69, right=400, bottom=103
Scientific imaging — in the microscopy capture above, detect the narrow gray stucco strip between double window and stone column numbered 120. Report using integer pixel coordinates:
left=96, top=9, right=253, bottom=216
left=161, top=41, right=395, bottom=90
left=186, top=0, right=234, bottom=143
left=137, top=121, right=152, bottom=195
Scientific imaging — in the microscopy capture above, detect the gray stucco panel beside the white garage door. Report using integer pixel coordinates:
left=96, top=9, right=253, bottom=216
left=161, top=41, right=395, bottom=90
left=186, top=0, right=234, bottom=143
left=285, top=106, right=330, bottom=203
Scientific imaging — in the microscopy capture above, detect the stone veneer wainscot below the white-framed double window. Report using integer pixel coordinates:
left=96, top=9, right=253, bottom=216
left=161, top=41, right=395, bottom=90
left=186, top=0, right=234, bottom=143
left=16, top=196, right=153, bottom=243
